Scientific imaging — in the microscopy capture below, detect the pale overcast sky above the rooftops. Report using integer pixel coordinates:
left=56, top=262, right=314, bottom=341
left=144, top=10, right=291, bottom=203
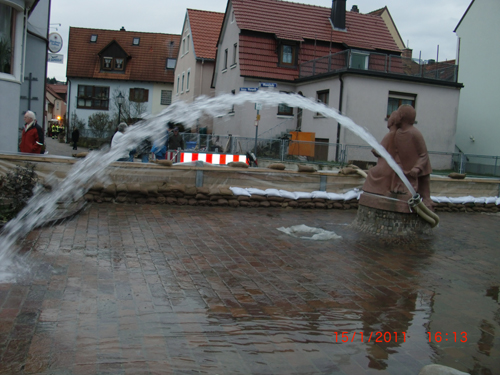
left=47, top=0, right=472, bottom=81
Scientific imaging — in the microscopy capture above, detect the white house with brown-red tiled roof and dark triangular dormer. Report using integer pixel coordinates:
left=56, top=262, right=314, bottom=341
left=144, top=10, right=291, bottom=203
left=66, top=27, right=180, bottom=130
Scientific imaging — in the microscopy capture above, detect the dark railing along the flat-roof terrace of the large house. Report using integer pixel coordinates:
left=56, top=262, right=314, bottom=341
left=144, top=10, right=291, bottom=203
left=299, top=49, right=458, bottom=82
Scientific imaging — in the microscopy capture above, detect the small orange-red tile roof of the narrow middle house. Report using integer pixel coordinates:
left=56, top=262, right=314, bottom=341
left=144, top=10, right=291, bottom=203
left=187, top=9, right=224, bottom=60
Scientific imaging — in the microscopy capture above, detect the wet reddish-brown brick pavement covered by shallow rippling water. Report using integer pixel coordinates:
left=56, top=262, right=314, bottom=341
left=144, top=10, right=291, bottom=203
left=0, top=204, right=500, bottom=375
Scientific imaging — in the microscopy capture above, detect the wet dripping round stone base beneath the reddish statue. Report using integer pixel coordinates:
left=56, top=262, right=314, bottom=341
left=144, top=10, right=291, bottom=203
left=353, top=204, right=432, bottom=237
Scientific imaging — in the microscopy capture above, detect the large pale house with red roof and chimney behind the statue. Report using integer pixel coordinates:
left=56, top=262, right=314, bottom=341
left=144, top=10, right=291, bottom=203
left=213, top=0, right=462, bottom=168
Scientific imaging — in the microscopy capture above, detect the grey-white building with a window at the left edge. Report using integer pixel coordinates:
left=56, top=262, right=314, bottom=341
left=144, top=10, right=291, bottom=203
left=0, top=0, right=50, bottom=152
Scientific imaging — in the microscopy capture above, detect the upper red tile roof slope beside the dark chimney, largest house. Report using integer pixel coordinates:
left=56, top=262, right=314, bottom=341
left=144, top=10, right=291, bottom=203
left=232, top=0, right=400, bottom=53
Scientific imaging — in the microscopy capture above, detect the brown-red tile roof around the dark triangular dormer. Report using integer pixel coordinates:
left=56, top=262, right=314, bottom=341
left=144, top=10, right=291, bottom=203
left=66, top=27, right=180, bottom=83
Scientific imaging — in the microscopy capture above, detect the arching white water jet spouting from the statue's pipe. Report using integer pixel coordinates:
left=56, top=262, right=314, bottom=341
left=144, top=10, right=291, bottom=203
left=0, top=92, right=415, bottom=279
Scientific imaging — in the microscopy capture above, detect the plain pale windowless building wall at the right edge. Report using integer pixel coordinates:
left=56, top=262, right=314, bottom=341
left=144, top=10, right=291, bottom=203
left=455, top=0, right=500, bottom=171
